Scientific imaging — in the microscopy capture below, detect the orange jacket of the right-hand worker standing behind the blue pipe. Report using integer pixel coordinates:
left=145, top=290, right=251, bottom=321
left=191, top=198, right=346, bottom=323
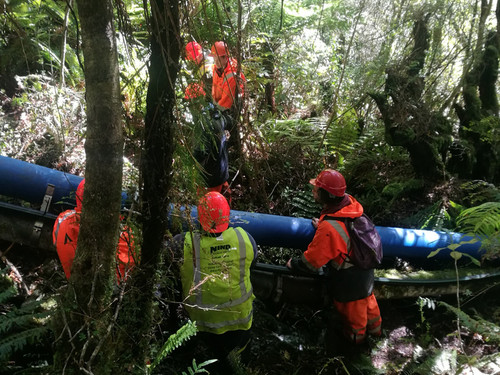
left=212, top=58, right=246, bottom=111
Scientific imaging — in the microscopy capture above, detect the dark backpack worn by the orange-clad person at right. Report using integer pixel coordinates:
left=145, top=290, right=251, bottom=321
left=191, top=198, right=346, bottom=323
left=334, top=214, right=383, bottom=270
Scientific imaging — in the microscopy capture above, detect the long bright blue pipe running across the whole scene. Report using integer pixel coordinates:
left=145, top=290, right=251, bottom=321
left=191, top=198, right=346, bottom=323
left=0, top=156, right=481, bottom=259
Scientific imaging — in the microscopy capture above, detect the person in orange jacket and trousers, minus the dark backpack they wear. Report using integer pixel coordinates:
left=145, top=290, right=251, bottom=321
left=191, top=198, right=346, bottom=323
left=287, top=169, right=382, bottom=344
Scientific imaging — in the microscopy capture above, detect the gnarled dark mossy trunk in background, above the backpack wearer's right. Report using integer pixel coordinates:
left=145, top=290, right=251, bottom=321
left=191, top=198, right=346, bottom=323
left=370, top=16, right=452, bottom=181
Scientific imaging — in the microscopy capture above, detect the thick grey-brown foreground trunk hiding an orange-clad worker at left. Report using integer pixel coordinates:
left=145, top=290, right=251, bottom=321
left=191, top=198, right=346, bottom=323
left=55, top=0, right=123, bottom=374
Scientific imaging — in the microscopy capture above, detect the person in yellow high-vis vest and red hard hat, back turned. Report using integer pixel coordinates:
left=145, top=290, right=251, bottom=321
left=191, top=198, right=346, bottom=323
left=173, top=191, right=257, bottom=373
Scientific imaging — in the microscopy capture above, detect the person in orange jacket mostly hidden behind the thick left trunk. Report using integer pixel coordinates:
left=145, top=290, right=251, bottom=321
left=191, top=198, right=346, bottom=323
left=52, top=179, right=135, bottom=282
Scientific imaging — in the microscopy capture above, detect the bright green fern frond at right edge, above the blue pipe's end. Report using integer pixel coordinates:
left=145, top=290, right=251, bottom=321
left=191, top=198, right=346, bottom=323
left=457, top=202, right=500, bottom=236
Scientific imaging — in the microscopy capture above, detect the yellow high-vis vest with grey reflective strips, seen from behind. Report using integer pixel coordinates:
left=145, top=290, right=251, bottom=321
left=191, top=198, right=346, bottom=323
left=181, top=227, right=255, bottom=334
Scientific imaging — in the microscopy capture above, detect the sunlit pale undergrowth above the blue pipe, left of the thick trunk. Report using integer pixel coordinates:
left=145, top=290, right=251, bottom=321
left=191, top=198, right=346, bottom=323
left=0, top=75, right=86, bottom=174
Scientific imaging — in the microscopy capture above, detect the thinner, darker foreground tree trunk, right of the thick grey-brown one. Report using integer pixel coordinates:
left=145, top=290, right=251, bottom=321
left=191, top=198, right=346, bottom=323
left=113, top=0, right=181, bottom=373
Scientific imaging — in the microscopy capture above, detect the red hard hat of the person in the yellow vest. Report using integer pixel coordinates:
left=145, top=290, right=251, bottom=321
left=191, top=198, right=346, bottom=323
left=198, top=191, right=230, bottom=233
